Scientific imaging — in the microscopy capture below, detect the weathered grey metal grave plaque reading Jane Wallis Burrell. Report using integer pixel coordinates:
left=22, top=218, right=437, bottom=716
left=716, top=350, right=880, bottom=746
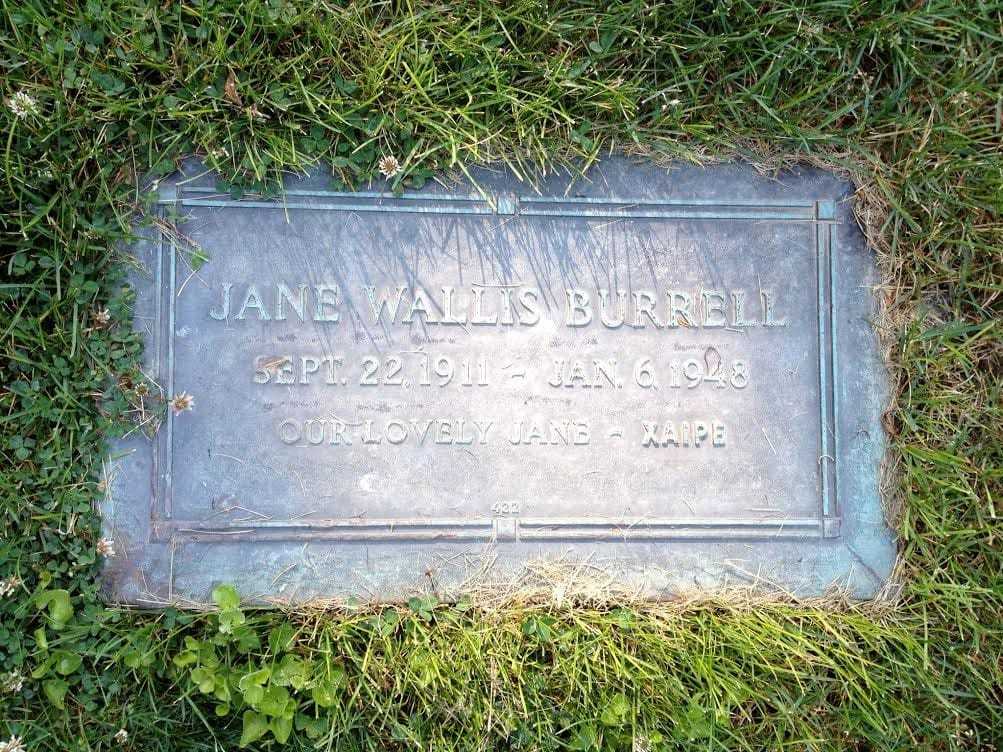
left=103, top=158, right=895, bottom=605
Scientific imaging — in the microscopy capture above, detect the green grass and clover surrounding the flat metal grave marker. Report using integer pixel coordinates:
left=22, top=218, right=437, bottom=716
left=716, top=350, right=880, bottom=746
left=0, top=0, right=1003, bottom=752
